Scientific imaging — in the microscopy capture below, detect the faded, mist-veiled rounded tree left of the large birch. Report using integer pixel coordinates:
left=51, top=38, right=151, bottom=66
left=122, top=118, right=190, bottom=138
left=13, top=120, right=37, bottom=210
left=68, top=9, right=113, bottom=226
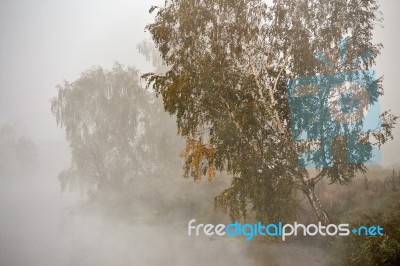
left=51, top=63, right=180, bottom=194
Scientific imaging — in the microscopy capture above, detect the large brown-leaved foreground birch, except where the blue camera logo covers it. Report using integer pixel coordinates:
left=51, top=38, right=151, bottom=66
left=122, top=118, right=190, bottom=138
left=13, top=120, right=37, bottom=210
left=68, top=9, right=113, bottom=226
left=144, top=0, right=396, bottom=223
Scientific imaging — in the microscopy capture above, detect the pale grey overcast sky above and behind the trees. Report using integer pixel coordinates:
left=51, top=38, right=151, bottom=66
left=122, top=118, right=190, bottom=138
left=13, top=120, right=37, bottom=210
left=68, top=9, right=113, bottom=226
left=0, top=0, right=400, bottom=165
